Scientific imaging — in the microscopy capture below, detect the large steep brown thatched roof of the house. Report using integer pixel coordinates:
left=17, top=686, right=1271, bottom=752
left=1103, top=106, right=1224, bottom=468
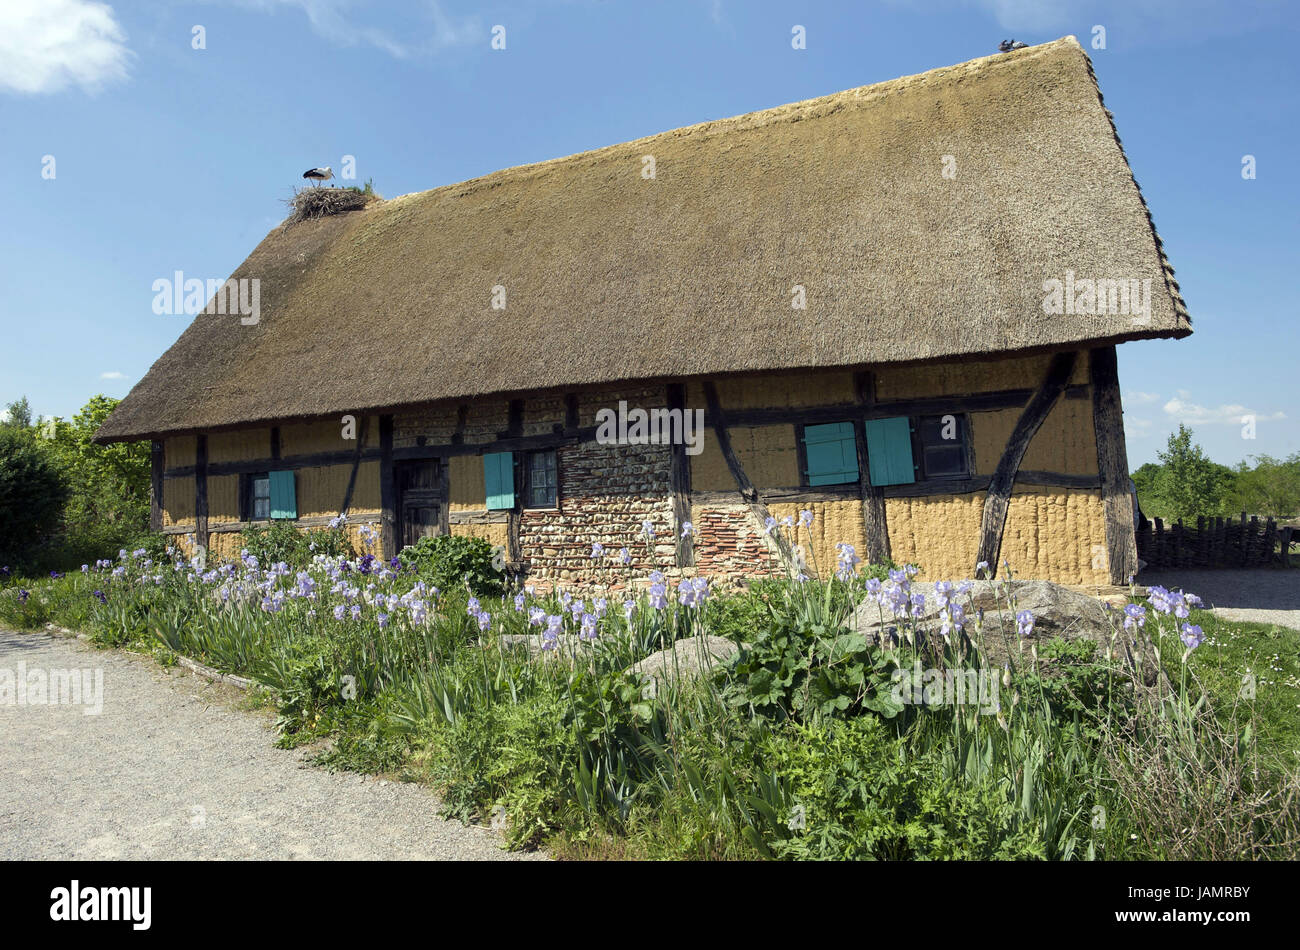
left=98, top=36, right=1191, bottom=441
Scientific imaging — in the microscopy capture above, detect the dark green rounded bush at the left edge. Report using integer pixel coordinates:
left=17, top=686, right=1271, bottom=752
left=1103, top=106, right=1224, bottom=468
left=0, top=423, right=68, bottom=565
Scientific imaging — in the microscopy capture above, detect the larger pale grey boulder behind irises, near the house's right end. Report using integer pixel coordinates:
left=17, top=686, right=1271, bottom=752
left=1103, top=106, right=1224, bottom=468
left=852, top=581, right=1154, bottom=680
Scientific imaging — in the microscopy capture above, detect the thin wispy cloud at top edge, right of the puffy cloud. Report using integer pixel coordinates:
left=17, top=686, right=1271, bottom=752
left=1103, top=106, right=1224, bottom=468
left=235, top=0, right=478, bottom=58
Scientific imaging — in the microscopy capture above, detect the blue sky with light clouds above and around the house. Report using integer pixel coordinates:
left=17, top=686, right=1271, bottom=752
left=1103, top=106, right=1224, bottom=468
left=0, top=0, right=1300, bottom=467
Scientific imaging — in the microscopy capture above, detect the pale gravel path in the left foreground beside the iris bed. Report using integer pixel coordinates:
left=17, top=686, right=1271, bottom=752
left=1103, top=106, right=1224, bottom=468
left=0, top=630, right=541, bottom=860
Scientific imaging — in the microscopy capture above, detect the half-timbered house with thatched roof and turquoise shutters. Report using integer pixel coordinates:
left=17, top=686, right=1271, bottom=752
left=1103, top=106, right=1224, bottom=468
left=98, top=38, right=1191, bottom=584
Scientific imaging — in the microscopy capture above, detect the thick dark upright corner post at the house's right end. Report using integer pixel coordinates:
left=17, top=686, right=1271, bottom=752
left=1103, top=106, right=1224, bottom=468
left=1088, top=346, right=1138, bottom=584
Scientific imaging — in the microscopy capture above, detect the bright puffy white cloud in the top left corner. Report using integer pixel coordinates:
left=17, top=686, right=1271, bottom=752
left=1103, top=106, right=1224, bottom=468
left=0, top=0, right=131, bottom=95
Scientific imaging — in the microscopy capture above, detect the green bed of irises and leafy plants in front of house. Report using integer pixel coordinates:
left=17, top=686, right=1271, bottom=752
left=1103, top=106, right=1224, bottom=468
left=12, top=535, right=1300, bottom=860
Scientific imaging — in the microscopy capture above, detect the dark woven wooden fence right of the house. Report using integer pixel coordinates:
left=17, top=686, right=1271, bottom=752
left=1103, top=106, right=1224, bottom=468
left=1138, top=512, right=1300, bottom=569
